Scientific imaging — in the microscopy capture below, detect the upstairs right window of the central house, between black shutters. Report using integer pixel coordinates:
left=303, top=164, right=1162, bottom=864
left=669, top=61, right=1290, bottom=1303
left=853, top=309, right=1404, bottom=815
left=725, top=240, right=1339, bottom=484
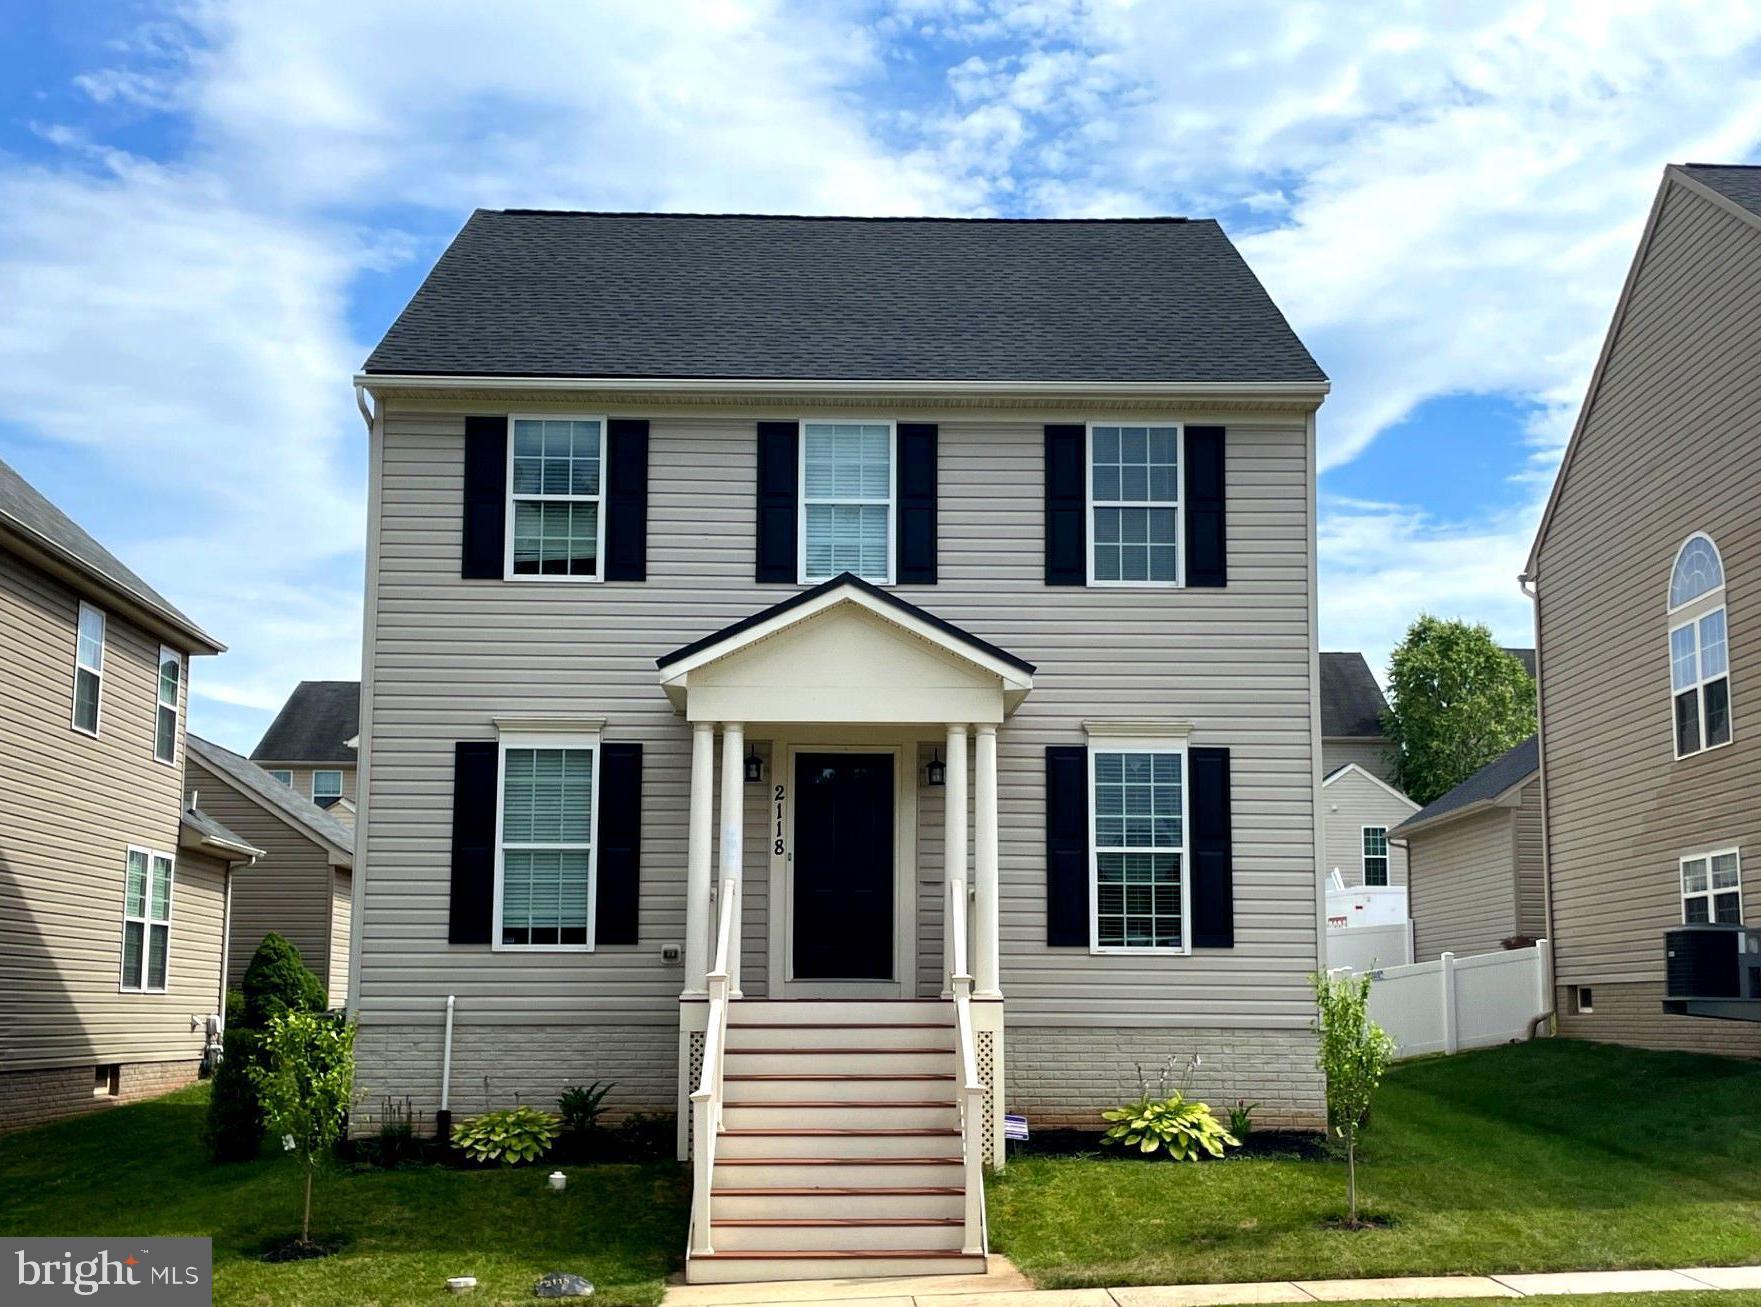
left=1088, top=423, right=1182, bottom=585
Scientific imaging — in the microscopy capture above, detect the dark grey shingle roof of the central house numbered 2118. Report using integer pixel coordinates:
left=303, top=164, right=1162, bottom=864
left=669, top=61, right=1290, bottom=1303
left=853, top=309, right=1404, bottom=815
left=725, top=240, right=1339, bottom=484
left=365, top=210, right=1326, bottom=384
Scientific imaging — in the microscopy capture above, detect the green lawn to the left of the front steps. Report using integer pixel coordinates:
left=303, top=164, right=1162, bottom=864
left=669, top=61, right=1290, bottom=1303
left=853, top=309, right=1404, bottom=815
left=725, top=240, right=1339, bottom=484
left=0, top=1087, right=687, bottom=1307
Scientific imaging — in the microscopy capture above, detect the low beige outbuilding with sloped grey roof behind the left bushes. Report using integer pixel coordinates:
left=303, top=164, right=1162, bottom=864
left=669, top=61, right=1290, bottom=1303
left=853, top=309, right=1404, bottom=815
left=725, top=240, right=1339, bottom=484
left=185, top=735, right=354, bottom=1008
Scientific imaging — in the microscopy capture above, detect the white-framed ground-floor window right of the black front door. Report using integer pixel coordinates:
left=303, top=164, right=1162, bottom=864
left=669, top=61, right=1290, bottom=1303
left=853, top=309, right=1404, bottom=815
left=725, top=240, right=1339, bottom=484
left=1088, top=742, right=1189, bottom=953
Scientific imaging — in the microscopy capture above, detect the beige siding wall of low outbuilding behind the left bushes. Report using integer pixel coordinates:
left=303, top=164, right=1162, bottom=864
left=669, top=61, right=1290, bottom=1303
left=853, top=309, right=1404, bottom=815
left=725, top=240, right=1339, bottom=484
left=190, top=757, right=340, bottom=1001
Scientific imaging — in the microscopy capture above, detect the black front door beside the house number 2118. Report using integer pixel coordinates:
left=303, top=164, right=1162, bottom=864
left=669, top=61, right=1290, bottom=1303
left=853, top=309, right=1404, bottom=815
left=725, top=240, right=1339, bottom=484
left=791, top=752, right=893, bottom=981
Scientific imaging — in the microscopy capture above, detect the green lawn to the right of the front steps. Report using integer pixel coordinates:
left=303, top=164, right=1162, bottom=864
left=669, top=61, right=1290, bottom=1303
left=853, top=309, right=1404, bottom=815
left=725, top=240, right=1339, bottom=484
left=988, top=1039, right=1761, bottom=1307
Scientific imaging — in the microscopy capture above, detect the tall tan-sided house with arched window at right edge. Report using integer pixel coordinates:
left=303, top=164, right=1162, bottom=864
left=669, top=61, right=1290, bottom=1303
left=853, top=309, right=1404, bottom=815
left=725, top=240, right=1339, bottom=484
left=1525, top=164, right=1761, bottom=1057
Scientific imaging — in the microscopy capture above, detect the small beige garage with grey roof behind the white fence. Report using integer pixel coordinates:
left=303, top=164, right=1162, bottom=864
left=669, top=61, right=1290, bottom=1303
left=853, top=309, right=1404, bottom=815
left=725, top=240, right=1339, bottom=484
left=1389, top=736, right=1546, bottom=962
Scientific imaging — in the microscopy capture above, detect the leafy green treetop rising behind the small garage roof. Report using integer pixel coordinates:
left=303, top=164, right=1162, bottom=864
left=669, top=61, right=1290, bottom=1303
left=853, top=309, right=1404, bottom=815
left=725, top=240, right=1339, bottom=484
left=1382, top=615, right=1536, bottom=803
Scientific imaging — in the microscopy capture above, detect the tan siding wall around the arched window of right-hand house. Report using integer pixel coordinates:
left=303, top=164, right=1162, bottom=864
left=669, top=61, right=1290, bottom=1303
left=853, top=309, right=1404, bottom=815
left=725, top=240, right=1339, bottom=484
left=1537, top=185, right=1761, bottom=1014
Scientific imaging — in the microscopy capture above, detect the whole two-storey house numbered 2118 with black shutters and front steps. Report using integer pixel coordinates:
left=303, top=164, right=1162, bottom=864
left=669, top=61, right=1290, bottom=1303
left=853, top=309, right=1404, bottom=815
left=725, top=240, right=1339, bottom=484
left=354, top=211, right=1328, bottom=1281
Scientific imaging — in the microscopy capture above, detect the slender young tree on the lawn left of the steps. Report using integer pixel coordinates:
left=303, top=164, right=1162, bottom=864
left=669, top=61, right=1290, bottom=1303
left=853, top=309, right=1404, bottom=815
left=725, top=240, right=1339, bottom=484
left=250, top=1011, right=354, bottom=1244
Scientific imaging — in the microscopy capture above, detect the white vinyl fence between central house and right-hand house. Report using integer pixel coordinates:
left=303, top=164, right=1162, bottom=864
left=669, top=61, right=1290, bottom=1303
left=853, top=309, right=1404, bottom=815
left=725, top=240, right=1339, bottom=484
left=1330, top=939, right=1553, bottom=1057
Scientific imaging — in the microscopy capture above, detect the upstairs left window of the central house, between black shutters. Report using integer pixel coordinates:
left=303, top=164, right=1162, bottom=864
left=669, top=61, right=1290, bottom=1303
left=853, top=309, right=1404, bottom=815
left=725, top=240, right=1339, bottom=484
left=507, top=417, right=606, bottom=581
